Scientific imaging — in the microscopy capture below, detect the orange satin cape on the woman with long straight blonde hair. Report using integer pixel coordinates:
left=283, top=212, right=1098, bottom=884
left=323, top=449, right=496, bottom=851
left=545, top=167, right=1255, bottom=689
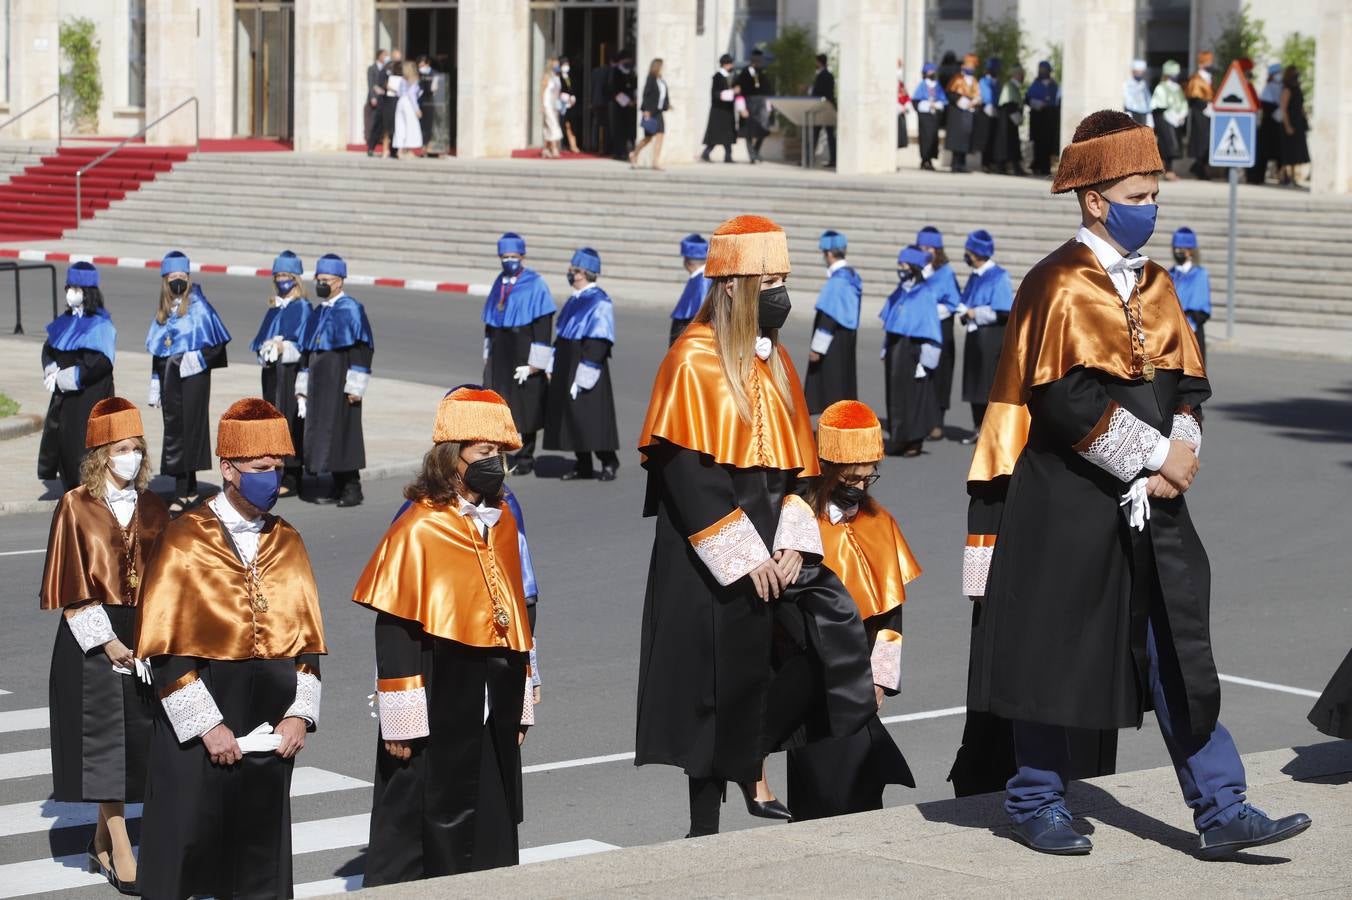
left=638, top=324, right=821, bottom=477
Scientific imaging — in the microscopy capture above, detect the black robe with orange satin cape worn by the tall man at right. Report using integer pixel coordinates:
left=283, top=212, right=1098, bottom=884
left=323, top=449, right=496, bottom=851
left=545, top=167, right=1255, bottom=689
left=968, top=241, right=1220, bottom=734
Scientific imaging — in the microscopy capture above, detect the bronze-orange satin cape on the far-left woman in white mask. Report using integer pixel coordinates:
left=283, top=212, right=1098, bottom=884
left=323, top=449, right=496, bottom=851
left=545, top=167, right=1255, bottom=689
left=39, top=485, right=169, bottom=609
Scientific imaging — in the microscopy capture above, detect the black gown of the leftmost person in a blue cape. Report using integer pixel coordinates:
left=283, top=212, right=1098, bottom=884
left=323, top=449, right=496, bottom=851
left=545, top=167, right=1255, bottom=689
left=38, top=342, right=112, bottom=491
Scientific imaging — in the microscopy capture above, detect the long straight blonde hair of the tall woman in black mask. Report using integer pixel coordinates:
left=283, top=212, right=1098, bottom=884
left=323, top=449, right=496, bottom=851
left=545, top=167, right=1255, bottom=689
left=695, top=276, right=794, bottom=424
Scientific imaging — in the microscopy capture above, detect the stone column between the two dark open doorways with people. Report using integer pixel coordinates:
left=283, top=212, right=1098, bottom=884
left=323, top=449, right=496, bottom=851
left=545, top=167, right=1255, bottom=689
left=456, top=0, right=533, bottom=159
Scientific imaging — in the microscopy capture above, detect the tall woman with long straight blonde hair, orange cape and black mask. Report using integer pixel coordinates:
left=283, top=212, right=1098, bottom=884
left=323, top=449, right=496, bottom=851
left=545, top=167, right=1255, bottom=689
left=635, top=216, right=876, bottom=836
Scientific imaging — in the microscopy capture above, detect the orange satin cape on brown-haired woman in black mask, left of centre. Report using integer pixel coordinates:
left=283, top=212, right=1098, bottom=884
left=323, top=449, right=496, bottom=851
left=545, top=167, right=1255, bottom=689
left=352, top=501, right=531, bottom=653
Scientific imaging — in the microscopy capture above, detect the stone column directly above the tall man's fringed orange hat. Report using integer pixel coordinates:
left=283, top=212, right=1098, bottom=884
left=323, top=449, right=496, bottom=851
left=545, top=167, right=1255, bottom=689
left=1056, top=0, right=1136, bottom=145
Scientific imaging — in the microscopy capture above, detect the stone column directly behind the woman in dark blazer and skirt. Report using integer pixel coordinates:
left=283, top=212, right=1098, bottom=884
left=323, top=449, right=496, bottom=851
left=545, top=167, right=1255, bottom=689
left=635, top=0, right=697, bottom=165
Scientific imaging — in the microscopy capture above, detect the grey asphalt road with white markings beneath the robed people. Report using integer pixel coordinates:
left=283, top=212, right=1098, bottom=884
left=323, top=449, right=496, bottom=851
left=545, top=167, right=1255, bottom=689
left=0, top=264, right=1352, bottom=896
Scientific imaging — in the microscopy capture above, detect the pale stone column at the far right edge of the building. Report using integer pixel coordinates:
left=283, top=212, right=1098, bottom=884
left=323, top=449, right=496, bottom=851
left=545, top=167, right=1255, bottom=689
left=1306, top=0, right=1352, bottom=195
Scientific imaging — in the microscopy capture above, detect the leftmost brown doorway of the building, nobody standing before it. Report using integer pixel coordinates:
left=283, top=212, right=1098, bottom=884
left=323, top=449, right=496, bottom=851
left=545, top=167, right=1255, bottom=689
left=234, top=0, right=296, bottom=141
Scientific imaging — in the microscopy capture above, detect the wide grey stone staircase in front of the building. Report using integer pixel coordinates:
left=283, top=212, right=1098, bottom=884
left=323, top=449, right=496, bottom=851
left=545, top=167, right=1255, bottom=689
left=68, top=153, right=1352, bottom=332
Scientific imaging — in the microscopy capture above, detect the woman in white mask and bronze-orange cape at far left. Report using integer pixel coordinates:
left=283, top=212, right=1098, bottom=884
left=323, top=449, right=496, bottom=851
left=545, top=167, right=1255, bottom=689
left=41, top=397, right=169, bottom=892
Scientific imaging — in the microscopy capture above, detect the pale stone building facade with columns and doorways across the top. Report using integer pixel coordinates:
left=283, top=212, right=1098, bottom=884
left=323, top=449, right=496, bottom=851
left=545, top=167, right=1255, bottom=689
left=0, top=0, right=1352, bottom=192
